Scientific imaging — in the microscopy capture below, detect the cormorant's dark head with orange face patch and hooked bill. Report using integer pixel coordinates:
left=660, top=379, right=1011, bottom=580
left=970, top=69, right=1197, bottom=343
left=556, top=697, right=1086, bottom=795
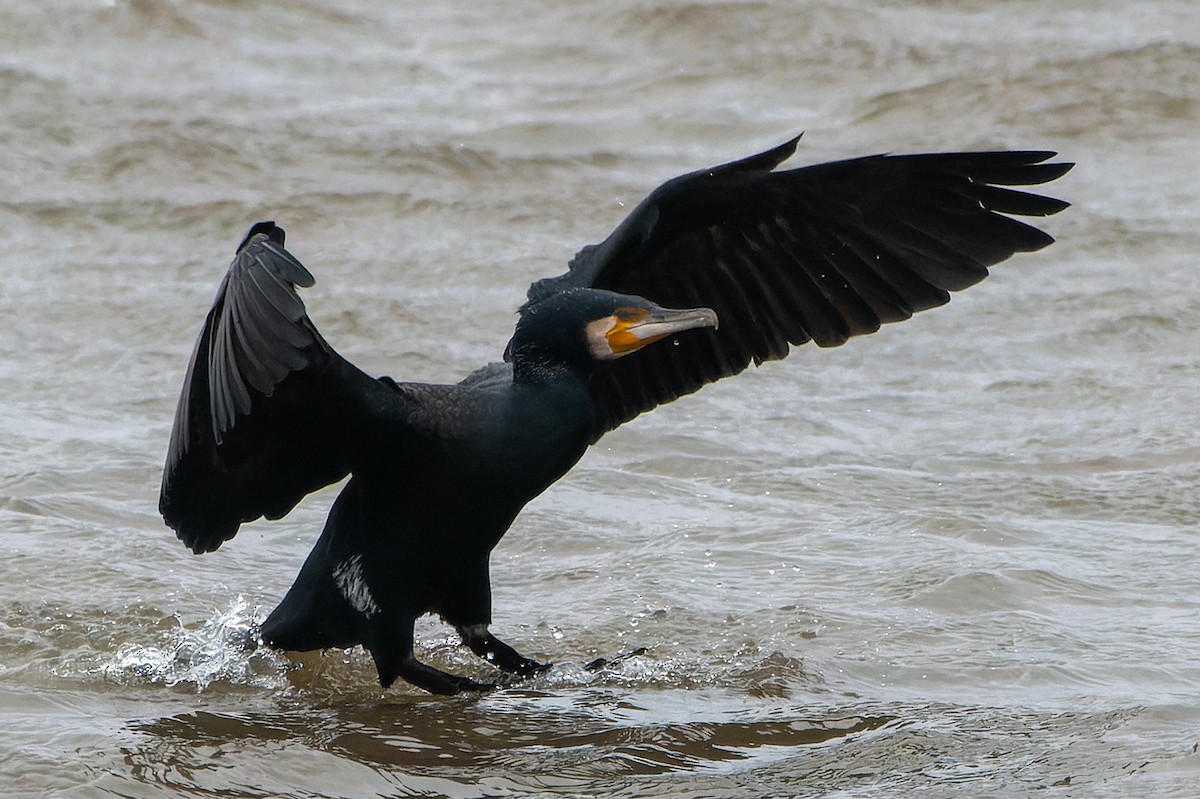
left=504, top=288, right=716, bottom=372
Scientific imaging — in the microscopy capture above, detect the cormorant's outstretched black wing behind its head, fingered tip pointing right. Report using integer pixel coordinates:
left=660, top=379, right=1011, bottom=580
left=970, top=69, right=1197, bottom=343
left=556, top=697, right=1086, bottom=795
left=529, top=138, right=1074, bottom=433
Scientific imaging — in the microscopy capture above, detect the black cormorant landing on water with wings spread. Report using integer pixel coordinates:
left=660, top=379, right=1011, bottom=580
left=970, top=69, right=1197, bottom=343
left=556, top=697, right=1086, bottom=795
left=158, top=137, right=1073, bottom=693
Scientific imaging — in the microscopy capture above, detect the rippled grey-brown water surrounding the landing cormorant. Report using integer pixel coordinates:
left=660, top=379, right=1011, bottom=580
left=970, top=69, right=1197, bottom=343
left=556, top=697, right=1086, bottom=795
left=0, top=0, right=1200, bottom=799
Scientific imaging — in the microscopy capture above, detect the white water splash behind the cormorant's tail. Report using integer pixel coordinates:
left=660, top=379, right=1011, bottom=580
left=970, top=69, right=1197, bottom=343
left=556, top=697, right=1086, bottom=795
left=97, top=596, right=289, bottom=692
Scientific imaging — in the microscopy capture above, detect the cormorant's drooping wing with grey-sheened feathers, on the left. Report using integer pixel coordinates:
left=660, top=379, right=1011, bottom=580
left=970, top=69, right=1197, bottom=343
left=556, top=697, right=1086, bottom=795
left=158, top=222, right=380, bottom=552
